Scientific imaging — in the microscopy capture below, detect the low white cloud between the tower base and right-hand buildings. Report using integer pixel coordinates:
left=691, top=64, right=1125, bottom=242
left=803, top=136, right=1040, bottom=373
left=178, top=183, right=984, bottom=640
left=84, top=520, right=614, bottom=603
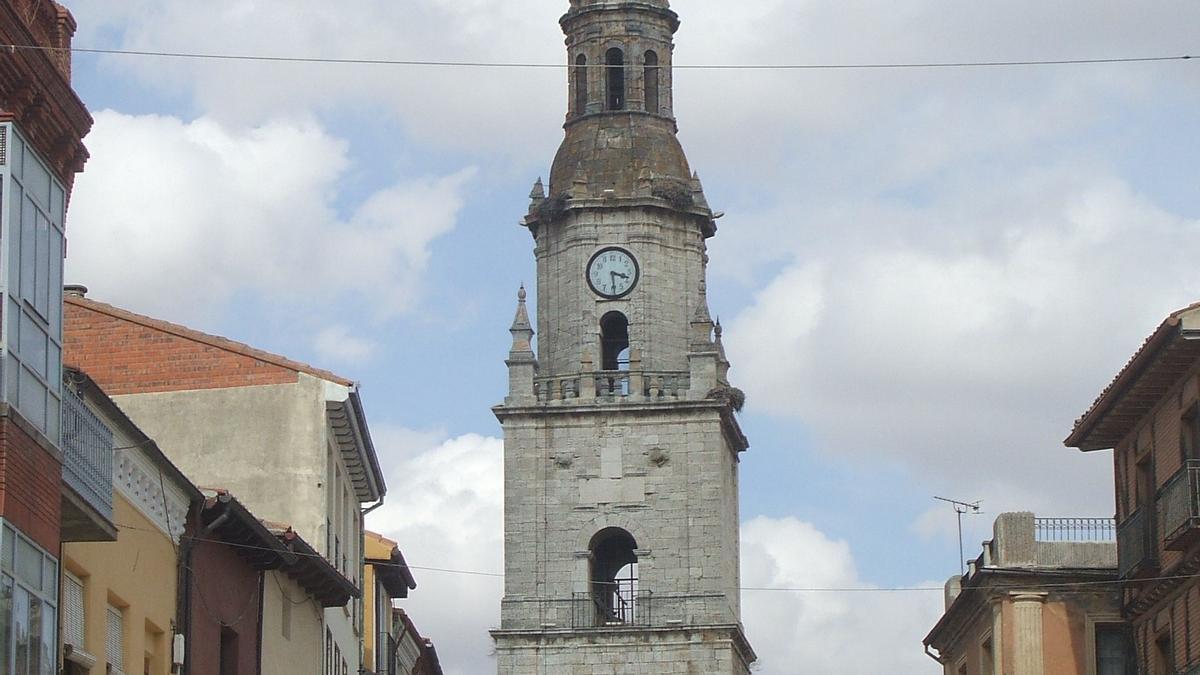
left=742, top=518, right=942, bottom=675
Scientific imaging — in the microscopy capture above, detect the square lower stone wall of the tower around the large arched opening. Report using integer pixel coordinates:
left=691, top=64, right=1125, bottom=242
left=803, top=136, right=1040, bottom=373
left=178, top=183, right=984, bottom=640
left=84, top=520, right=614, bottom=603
left=502, top=402, right=739, bottom=629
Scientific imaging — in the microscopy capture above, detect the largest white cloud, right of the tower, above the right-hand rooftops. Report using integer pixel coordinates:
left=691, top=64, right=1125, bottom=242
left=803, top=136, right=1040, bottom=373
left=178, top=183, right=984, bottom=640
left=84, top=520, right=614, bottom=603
left=726, top=167, right=1200, bottom=515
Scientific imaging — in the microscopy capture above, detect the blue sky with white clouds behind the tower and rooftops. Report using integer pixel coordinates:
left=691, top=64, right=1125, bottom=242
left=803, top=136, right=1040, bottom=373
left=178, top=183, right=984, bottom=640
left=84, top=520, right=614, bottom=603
left=49, top=0, right=1200, bottom=675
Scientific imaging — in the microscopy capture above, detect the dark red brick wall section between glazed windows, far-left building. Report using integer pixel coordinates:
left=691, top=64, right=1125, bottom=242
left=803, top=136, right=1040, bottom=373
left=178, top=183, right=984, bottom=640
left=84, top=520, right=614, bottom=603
left=0, top=412, right=62, bottom=555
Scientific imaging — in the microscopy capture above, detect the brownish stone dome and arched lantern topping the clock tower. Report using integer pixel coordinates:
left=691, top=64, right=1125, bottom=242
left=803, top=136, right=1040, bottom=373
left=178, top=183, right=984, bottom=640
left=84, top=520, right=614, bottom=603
left=529, top=0, right=712, bottom=218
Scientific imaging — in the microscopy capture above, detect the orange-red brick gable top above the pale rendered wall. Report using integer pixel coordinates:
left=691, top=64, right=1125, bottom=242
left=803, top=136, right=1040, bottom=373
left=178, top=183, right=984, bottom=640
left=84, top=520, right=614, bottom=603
left=62, top=303, right=298, bottom=395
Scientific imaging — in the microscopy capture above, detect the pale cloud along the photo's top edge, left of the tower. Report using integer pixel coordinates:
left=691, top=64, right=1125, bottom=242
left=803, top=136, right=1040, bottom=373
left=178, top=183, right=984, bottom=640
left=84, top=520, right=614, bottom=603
left=72, top=0, right=566, bottom=154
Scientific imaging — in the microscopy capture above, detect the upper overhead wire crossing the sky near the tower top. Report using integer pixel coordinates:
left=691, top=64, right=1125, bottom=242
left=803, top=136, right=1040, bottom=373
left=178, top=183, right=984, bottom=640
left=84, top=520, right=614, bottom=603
left=0, top=44, right=1196, bottom=71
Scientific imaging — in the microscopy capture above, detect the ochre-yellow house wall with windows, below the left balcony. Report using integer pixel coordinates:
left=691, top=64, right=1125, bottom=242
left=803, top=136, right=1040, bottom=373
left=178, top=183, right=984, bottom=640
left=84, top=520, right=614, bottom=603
left=62, top=491, right=176, bottom=675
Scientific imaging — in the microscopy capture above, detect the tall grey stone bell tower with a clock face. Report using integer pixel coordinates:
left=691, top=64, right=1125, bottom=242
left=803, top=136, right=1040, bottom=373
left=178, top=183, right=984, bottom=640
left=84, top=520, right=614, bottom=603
left=492, top=0, right=755, bottom=675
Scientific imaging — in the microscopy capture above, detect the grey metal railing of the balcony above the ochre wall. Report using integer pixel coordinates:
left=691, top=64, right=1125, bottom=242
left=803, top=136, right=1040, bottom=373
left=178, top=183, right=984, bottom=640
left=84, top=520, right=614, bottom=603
left=62, top=388, right=113, bottom=520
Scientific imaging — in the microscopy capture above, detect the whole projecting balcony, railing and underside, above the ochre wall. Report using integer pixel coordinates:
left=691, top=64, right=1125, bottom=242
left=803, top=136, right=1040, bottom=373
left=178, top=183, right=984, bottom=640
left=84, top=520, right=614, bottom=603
left=62, top=388, right=113, bottom=542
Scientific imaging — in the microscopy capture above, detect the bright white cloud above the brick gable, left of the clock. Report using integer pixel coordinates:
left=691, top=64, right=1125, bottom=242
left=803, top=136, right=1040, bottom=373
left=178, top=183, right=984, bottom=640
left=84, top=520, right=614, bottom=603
left=67, top=110, right=474, bottom=319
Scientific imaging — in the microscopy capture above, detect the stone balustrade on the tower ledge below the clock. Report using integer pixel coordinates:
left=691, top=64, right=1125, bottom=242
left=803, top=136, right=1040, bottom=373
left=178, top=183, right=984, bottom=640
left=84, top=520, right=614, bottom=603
left=534, top=370, right=691, bottom=404
